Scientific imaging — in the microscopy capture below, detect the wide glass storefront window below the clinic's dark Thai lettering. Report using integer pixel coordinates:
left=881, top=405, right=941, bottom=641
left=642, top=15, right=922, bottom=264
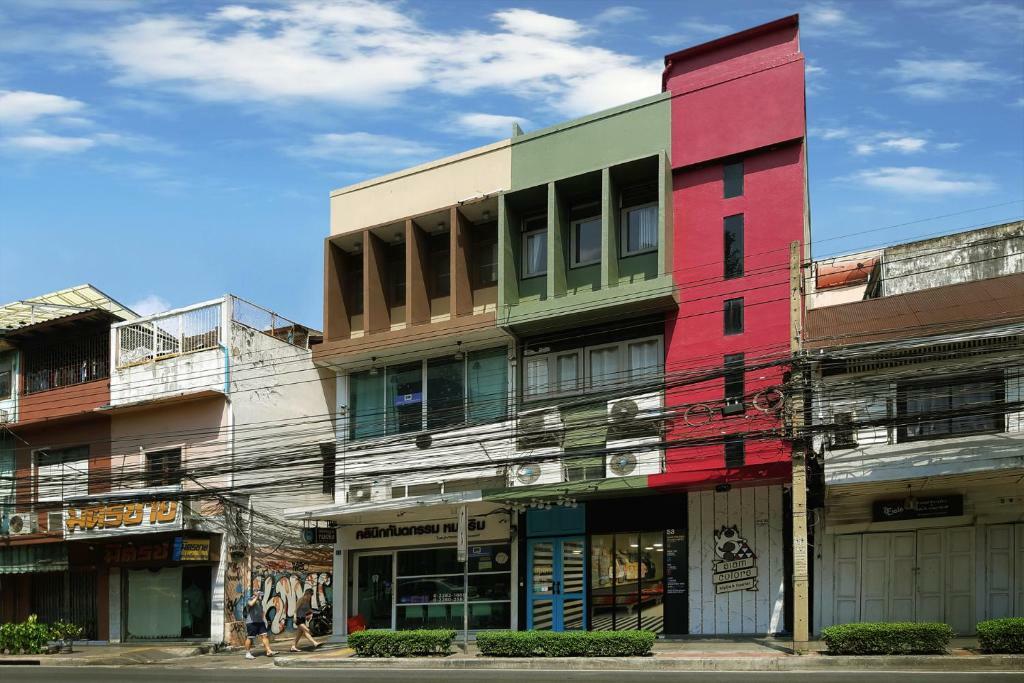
left=385, top=544, right=512, bottom=631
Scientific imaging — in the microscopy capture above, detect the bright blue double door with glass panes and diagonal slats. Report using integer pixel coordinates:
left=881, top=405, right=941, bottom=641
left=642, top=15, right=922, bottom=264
left=526, top=537, right=587, bottom=631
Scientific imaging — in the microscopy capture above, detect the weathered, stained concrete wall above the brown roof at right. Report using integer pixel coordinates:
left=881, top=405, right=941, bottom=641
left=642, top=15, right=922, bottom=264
left=882, top=221, right=1024, bottom=296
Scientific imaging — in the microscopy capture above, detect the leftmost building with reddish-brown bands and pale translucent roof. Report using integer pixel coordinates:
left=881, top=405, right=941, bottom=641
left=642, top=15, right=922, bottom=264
left=0, top=285, right=136, bottom=639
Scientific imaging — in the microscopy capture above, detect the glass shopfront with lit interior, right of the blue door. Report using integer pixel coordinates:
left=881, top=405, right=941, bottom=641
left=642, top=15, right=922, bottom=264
left=590, top=531, right=665, bottom=633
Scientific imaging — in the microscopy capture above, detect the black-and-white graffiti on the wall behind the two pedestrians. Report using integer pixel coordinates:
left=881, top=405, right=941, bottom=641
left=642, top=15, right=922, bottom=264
left=228, top=555, right=334, bottom=634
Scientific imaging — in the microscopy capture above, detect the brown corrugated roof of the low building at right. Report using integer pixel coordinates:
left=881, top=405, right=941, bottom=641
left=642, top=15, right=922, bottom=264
left=804, top=273, right=1024, bottom=349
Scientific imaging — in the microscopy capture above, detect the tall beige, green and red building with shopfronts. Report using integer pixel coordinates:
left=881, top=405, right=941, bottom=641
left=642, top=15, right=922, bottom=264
left=289, top=17, right=806, bottom=634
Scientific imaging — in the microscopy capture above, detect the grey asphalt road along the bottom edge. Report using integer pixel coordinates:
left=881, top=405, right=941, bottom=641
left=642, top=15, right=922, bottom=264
left=0, top=663, right=1024, bottom=683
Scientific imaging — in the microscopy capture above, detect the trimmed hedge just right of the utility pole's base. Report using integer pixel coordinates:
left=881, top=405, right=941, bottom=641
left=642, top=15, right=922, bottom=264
left=821, top=622, right=953, bottom=654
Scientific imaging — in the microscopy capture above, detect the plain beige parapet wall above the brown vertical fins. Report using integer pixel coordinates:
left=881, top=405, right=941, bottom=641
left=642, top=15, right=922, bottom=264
left=331, top=140, right=511, bottom=236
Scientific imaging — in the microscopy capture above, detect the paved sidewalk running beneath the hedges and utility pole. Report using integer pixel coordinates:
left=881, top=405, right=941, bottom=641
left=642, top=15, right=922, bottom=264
left=273, top=639, right=1024, bottom=672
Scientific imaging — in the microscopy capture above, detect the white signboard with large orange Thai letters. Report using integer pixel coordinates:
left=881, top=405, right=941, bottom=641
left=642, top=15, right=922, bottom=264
left=65, top=501, right=181, bottom=538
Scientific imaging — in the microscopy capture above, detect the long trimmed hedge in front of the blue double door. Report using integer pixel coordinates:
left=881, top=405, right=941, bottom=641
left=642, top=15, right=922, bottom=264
left=476, top=631, right=655, bottom=657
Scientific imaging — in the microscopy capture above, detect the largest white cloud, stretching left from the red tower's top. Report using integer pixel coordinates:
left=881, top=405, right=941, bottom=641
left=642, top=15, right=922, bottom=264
left=94, top=0, right=660, bottom=115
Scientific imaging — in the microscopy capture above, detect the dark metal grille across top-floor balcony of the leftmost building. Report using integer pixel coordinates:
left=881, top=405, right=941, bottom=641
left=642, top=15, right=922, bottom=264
left=25, top=332, right=111, bottom=393
